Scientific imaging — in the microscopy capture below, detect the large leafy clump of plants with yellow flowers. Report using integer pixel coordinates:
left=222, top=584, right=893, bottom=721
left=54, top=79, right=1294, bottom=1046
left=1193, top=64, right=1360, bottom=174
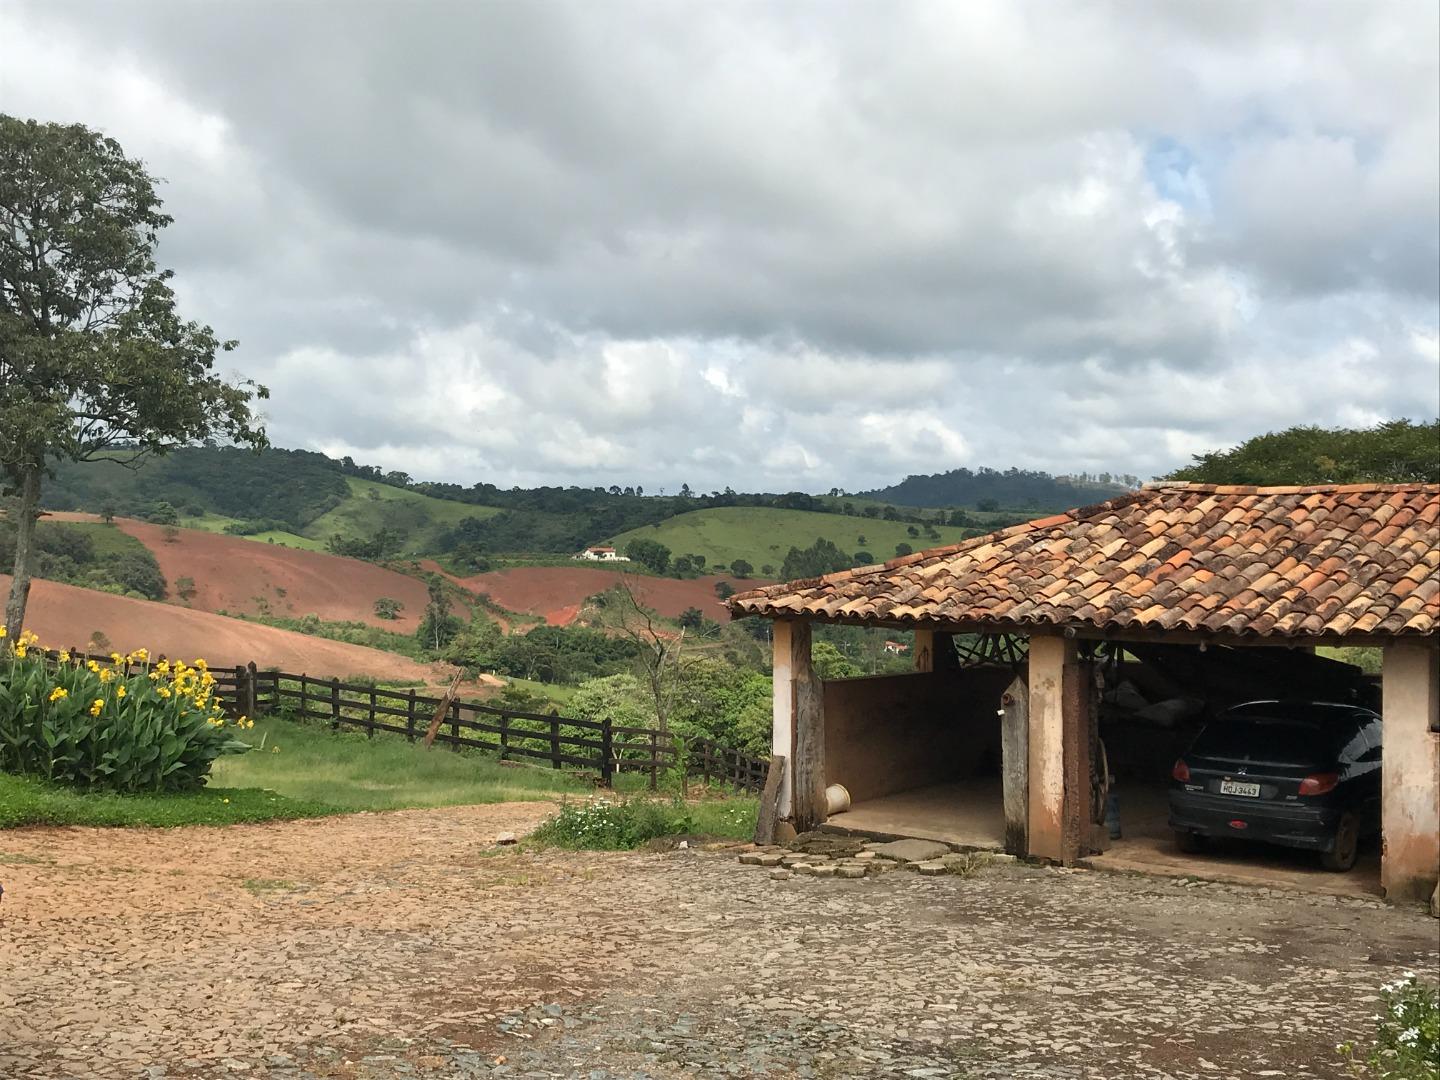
left=0, top=628, right=253, bottom=792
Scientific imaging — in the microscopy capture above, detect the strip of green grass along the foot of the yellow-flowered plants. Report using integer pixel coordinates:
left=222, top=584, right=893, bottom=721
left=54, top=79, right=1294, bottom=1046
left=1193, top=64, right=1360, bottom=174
left=0, top=771, right=340, bottom=829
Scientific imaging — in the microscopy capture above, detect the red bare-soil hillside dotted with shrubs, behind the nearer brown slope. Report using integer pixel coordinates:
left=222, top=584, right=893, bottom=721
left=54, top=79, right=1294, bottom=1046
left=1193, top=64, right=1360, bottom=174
left=48, top=513, right=443, bottom=634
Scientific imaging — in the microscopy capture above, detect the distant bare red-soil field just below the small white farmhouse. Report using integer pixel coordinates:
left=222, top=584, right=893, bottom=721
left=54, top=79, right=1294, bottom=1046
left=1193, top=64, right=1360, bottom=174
left=433, top=566, right=744, bottom=626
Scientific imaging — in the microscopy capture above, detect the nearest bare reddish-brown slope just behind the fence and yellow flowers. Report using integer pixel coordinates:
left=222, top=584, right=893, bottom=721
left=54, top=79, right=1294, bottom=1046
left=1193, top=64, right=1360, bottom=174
left=0, top=575, right=433, bottom=680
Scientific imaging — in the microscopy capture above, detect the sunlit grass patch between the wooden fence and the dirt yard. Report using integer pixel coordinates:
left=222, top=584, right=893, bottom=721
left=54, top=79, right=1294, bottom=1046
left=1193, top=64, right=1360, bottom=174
left=213, top=717, right=592, bottom=811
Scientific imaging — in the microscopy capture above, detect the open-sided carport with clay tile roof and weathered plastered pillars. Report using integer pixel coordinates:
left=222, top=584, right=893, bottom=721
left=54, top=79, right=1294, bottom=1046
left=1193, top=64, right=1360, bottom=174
left=729, top=484, right=1440, bottom=899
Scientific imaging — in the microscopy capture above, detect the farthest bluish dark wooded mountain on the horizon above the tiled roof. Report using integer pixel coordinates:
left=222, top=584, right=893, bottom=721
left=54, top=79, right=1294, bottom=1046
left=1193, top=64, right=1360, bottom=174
left=863, top=468, right=1139, bottom=510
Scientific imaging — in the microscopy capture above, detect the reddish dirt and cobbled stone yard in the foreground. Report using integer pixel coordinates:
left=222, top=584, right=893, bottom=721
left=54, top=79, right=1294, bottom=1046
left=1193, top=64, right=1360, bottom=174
left=0, top=804, right=1440, bottom=1080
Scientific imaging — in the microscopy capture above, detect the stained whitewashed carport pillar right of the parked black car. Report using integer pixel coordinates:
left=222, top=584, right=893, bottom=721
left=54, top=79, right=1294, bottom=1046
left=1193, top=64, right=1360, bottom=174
left=1380, top=639, right=1440, bottom=900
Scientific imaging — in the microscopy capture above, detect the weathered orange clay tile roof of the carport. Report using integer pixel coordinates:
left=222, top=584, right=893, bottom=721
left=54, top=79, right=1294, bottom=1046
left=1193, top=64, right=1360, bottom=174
left=729, top=484, right=1440, bottom=638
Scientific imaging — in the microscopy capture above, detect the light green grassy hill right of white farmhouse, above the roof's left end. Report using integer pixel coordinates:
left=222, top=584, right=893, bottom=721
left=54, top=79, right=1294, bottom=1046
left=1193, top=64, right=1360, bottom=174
left=615, top=507, right=966, bottom=573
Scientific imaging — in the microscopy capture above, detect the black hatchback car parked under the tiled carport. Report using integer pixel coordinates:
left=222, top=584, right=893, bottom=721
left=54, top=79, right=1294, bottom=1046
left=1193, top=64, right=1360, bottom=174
left=1169, top=701, right=1381, bottom=870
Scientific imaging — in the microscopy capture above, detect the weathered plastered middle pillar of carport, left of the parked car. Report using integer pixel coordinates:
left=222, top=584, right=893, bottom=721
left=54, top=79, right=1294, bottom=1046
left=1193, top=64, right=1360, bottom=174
left=1025, top=636, right=1076, bottom=860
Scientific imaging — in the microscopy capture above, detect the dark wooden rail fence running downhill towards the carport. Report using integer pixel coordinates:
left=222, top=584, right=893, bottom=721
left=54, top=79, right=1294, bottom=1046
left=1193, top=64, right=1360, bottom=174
left=210, top=664, right=769, bottom=791
